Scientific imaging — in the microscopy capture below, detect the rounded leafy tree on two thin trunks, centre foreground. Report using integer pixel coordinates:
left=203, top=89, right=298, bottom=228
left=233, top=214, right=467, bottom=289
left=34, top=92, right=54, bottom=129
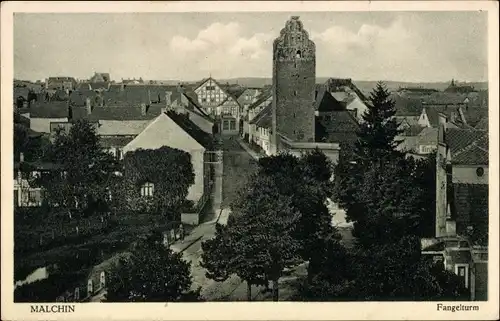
left=203, top=175, right=300, bottom=301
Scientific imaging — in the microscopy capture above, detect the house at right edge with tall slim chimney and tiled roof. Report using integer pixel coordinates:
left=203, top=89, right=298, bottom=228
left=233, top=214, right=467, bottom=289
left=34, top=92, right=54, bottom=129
left=422, top=114, right=489, bottom=300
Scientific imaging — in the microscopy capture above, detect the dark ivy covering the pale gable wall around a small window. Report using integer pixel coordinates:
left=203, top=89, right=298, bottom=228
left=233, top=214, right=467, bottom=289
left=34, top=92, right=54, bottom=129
left=123, top=146, right=194, bottom=219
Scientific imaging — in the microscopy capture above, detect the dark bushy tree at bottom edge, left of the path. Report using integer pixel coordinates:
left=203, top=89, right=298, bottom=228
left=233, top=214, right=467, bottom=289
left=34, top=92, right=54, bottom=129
left=106, top=233, right=199, bottom=302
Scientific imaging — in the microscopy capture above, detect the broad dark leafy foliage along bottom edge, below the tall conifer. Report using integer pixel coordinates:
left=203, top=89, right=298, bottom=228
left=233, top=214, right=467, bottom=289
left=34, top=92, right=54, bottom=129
left=301, top=236, right=468, bottom=301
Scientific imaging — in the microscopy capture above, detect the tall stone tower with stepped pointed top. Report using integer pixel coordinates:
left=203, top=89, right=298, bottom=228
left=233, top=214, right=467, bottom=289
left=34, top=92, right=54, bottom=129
left=271, top=16, right=316, bottom=153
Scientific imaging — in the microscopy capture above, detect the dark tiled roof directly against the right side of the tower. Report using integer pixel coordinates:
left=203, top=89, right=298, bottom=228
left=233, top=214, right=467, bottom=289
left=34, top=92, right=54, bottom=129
left=316, top=110, right=359, bottom=143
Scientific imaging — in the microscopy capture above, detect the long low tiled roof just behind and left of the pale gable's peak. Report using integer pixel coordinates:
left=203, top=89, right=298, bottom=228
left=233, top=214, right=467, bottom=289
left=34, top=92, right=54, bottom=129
left=73, top=105, right=163, bottom=121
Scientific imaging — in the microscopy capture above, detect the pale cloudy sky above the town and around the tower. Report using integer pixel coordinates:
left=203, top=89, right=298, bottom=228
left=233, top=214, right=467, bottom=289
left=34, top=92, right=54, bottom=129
left=14, top=11, right=488, bottom=82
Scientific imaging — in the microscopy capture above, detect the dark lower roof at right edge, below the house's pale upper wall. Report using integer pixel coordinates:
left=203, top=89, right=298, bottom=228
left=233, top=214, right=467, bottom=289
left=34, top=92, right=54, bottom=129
left=450, top=184, right=489, bottom=240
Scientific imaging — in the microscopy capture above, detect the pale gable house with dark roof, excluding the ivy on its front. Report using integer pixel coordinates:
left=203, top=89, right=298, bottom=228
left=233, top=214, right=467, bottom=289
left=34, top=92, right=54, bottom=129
left=123, top=111, right=213, bottom=203
